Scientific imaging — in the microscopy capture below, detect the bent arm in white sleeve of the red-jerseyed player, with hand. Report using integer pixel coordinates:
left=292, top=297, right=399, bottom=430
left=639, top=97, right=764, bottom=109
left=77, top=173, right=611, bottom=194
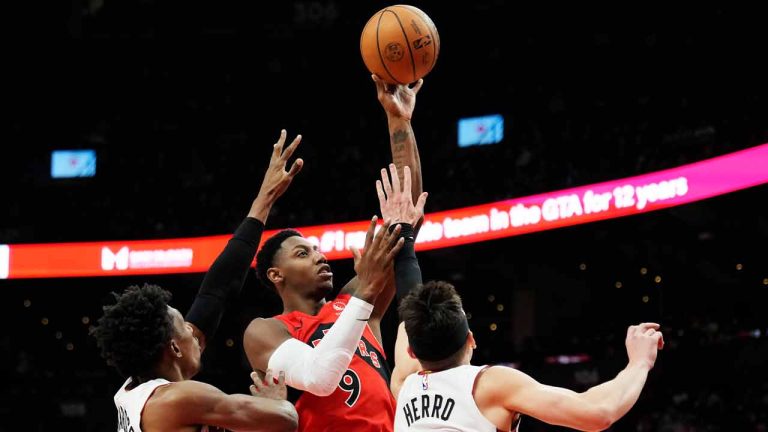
left=243, top=217, right=403, bottom=396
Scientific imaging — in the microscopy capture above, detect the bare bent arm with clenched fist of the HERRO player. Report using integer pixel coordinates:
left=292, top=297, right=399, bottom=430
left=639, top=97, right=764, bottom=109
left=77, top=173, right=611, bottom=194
left=474, top=323, right=664, bottom=431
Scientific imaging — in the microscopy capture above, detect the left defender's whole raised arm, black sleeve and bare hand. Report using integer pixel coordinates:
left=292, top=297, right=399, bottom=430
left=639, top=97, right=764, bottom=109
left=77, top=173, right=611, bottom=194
left=185, top=130, right=304, bottom=348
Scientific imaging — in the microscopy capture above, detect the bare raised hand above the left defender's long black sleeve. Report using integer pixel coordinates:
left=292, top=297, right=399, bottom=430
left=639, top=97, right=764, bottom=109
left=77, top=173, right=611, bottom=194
left=248, top=129, right=304, bottom=223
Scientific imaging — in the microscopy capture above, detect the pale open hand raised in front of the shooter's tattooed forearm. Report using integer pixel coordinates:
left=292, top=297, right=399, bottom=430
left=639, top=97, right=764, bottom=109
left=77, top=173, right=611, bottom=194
left=376, top=164, right=428, bottom=227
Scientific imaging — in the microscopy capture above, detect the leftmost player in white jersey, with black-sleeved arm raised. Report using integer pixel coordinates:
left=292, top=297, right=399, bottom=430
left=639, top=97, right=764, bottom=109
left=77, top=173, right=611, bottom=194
left=92, top=130, right=303, bottom=432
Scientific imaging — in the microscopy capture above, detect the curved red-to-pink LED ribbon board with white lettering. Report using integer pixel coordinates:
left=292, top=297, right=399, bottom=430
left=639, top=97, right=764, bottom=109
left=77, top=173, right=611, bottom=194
left=0, top=144, right=768, bottom=279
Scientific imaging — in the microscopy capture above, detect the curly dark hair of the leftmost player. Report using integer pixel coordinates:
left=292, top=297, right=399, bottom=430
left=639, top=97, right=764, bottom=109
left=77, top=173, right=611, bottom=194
left=91, top=284, right=174, bottom=378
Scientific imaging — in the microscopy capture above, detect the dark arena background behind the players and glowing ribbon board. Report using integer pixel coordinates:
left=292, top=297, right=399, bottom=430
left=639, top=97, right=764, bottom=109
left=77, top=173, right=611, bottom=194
left=0, top=0, right=768, bottom=432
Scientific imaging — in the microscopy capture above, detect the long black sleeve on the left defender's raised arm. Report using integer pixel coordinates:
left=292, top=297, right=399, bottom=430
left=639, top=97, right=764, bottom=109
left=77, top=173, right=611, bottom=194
left=185, top=217, right=264, bottom=341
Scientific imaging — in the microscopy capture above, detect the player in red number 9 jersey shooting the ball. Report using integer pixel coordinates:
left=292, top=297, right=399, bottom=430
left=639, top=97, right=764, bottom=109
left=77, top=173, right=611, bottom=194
left=243, top=76, right=426, bottom=431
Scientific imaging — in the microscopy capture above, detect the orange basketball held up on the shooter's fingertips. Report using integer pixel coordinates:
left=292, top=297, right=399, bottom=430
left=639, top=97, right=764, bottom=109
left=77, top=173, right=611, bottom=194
left=360, top=5, right=440, bottom=84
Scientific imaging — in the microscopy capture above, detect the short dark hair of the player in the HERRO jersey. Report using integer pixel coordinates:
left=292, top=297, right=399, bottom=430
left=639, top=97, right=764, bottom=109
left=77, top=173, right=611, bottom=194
left=398, top=281, right=469, bottom=364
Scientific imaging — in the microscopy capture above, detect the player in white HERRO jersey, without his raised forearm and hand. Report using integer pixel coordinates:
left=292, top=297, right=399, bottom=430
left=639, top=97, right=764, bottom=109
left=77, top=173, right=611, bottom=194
left=391, top=281, right=664, bottom=432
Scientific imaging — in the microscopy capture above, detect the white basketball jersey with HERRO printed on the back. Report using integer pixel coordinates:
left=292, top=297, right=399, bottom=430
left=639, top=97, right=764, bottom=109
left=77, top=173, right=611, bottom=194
left=395, top=365, right=516, bottom=432
